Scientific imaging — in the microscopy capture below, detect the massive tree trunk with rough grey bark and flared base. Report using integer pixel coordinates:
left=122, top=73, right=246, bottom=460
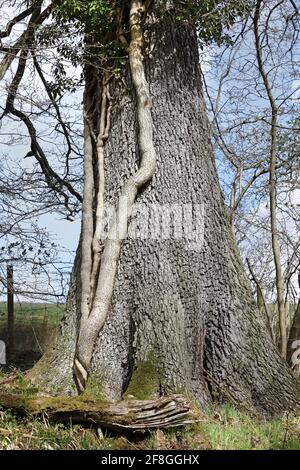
left=31, top=5, right=299, bottom=413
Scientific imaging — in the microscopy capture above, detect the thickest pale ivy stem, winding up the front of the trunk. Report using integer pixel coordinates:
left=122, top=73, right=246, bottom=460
left=74, top=0, right=156, bottom=391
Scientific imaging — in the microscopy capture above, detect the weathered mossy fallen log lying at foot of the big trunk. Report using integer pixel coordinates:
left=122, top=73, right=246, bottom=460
left=0, top=393, right=197, bottom=432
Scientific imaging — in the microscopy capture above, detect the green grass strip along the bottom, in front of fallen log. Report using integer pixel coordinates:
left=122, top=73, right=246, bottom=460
left=0, top=398, right=300, bottom=450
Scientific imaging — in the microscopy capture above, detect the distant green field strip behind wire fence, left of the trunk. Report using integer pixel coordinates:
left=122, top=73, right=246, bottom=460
left=0, top=302, right=64, bottom=325
